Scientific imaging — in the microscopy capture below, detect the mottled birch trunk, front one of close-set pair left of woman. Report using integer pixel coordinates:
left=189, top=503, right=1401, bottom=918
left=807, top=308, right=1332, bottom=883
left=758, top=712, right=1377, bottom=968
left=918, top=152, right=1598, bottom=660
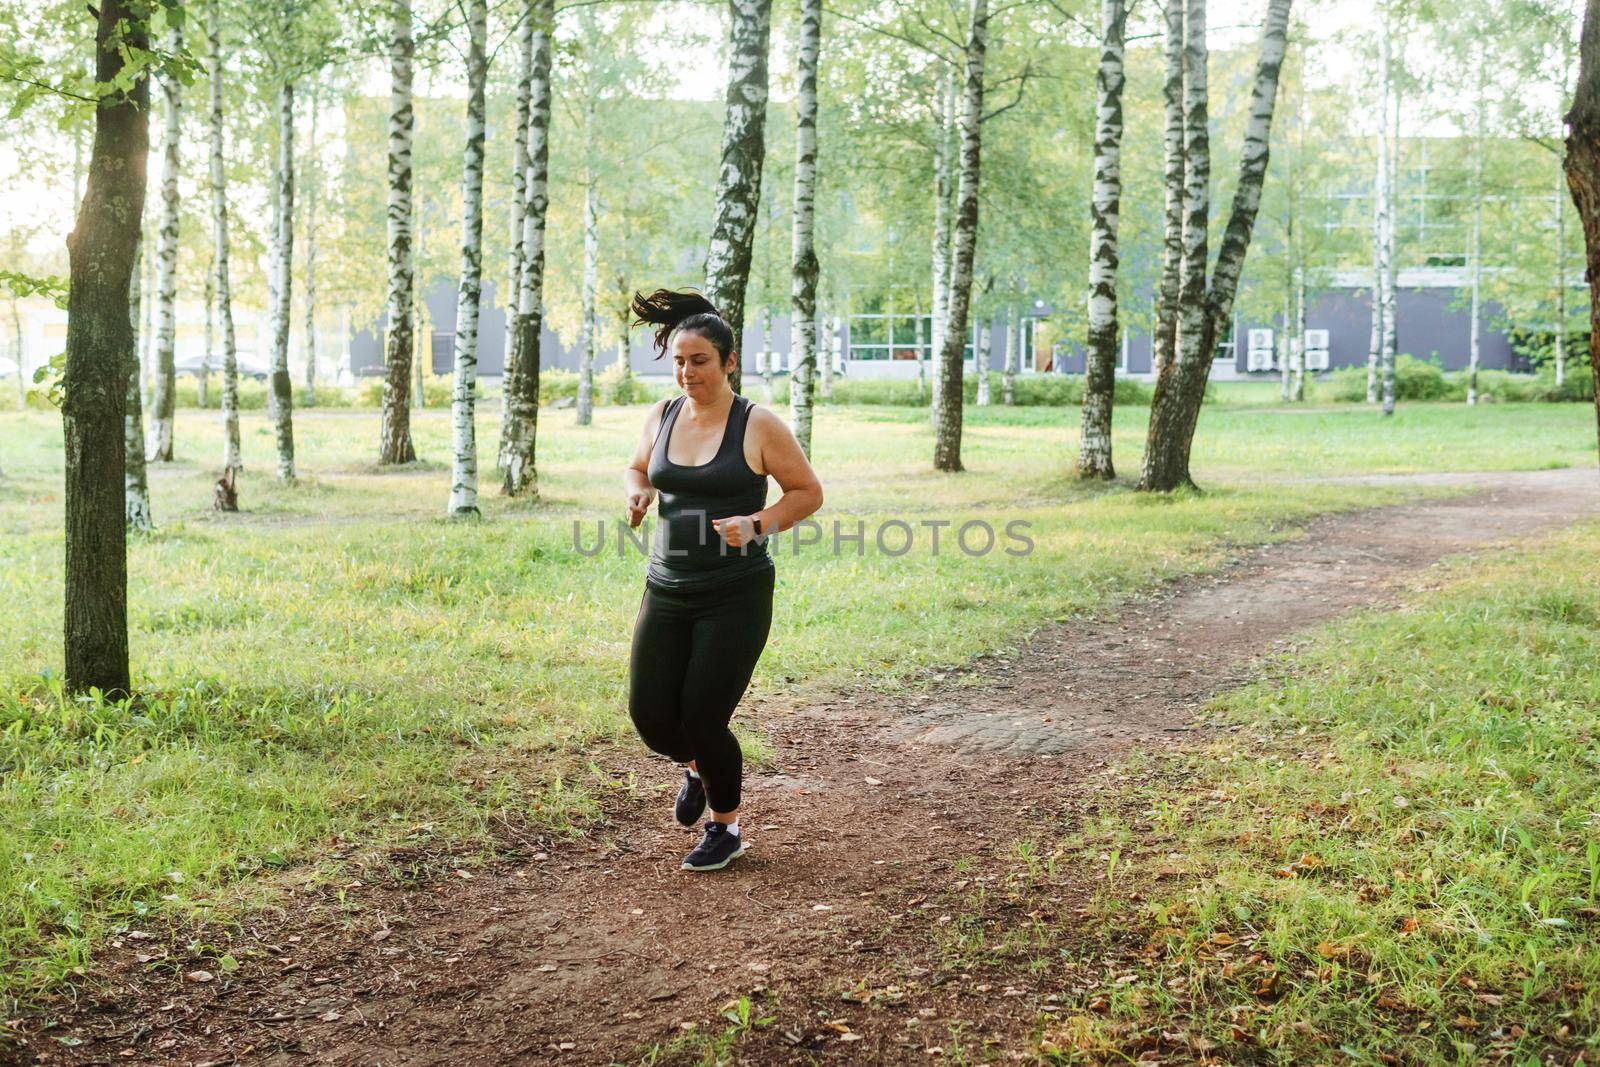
left=501, top=0, right=555, bottom=498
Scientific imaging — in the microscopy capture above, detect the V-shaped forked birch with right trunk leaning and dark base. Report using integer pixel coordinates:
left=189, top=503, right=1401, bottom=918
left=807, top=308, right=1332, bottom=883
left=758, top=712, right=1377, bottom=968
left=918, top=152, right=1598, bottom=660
left=1139, top=0, right=1290, bottom=493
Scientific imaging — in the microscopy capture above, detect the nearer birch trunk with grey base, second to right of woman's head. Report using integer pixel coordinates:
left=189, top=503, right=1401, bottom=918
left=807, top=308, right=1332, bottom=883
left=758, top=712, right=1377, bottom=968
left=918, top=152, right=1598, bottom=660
left=933, top=0, right=989, bottom=470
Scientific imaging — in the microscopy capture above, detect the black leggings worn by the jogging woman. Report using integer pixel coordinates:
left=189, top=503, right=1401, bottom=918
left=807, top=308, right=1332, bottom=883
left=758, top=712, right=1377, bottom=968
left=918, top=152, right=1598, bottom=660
left=627, top=568, right=776, bottom=813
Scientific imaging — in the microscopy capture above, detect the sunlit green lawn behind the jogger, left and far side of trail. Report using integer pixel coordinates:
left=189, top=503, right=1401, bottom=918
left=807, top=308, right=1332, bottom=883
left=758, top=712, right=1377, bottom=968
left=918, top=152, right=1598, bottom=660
left=0, top=394, right=1594, bottom=1003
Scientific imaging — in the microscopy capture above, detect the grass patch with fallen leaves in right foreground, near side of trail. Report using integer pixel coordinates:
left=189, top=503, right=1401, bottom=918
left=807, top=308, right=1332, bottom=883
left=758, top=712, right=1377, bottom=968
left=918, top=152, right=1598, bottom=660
left=1045, top=525, right=1600, bottom=1064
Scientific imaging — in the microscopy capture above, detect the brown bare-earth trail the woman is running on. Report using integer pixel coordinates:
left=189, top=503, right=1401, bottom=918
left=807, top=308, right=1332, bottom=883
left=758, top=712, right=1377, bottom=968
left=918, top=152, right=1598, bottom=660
left=24, top=469, right=1600, bottom=1064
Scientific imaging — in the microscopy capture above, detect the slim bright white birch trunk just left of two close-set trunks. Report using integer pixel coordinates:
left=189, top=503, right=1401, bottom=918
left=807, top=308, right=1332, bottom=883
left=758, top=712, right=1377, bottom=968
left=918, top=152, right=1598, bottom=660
left=450, top=0, right=490, bottom=518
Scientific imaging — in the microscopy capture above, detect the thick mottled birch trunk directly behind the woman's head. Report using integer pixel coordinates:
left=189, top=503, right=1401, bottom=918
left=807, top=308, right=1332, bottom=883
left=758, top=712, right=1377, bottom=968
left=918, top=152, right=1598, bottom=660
left=706, top=0, right=773, bottom=392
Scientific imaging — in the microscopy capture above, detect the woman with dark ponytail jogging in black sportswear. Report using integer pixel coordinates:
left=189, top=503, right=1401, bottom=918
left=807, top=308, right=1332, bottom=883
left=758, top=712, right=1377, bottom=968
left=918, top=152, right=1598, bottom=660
left=622, top=290, right=822, bottom=870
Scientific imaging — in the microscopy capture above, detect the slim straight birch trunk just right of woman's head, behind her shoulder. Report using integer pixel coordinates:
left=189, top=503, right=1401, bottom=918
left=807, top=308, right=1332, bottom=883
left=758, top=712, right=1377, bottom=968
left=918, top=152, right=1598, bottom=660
left=789, top=0, right=819, bottom=458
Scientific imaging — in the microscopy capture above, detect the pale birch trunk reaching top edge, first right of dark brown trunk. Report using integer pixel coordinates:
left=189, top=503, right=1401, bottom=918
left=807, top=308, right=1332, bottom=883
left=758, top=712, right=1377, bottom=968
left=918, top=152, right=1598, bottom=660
left=147, top=6, right=184, bottom=462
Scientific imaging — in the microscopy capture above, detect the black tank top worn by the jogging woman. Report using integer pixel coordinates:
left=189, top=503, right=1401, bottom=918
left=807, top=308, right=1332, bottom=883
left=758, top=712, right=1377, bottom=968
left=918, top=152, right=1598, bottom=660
left=646, top=394, right=773, bottom=590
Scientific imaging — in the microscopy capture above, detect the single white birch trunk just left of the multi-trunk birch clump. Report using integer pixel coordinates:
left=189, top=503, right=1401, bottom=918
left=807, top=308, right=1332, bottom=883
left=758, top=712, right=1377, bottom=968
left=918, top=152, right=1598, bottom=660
left=1078, top=0, right=1128, bottom=480
